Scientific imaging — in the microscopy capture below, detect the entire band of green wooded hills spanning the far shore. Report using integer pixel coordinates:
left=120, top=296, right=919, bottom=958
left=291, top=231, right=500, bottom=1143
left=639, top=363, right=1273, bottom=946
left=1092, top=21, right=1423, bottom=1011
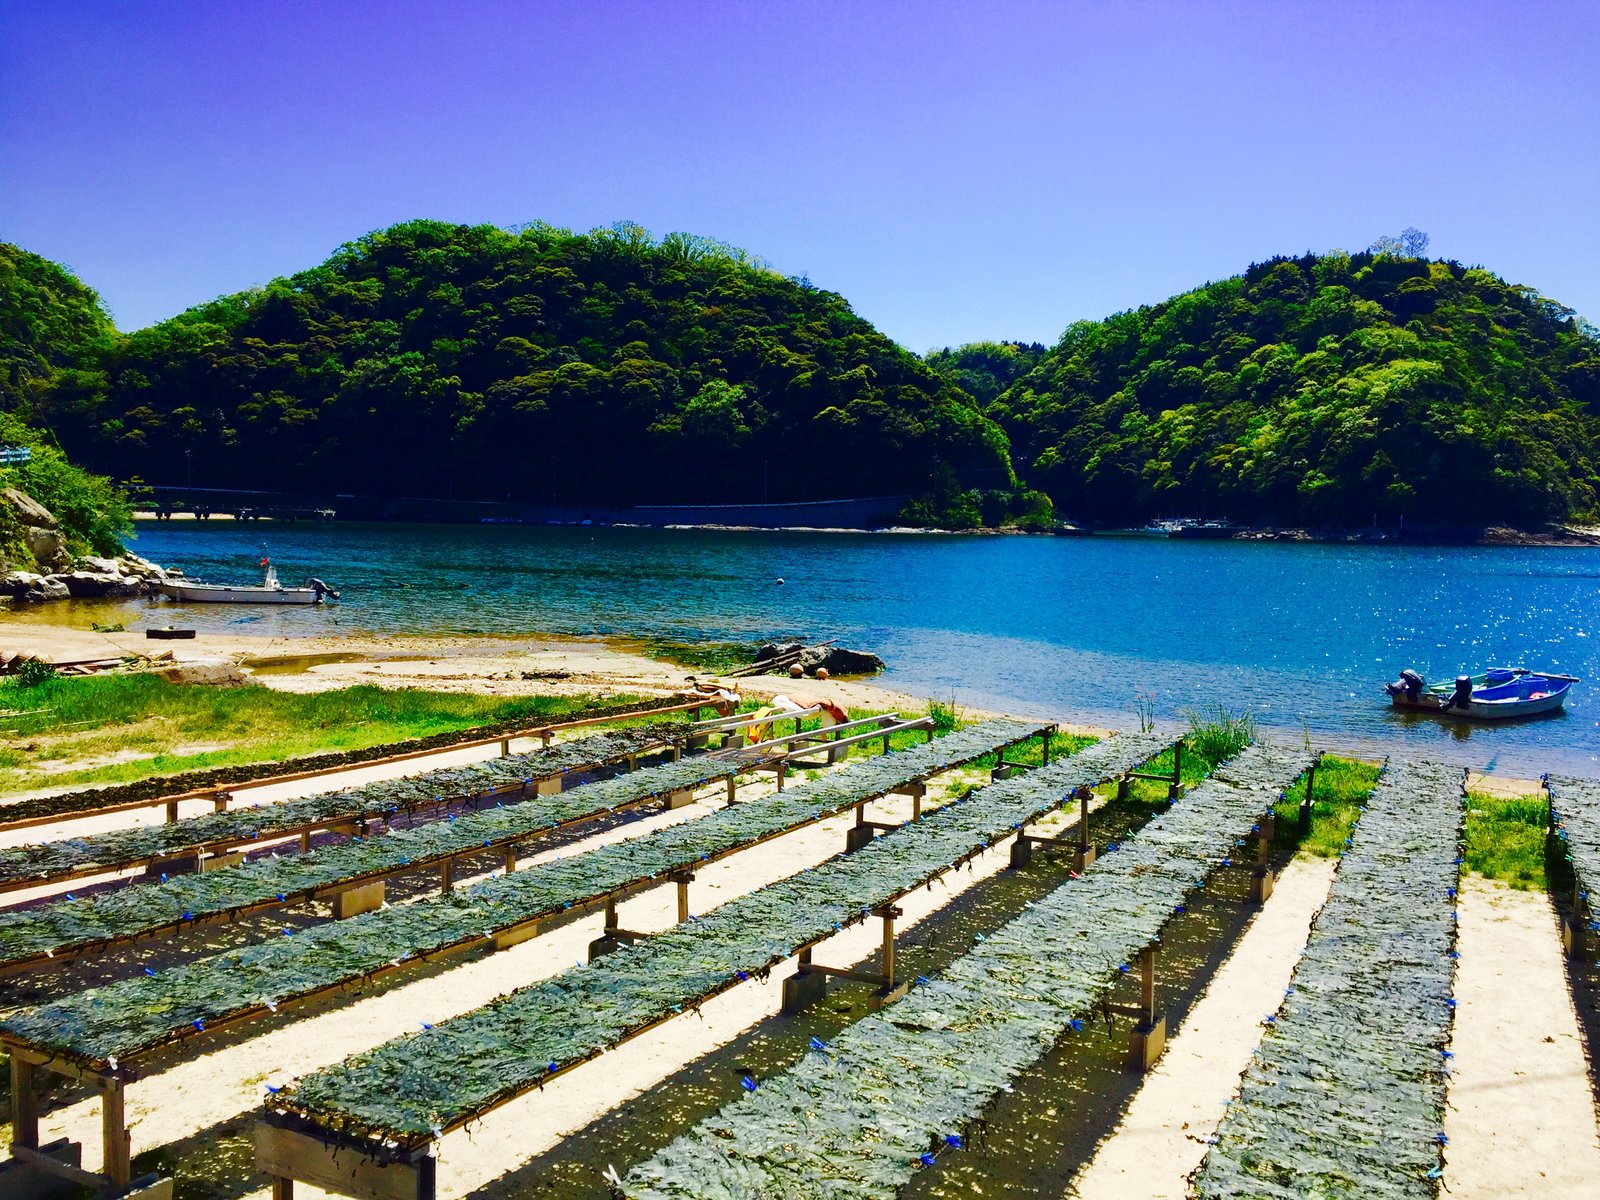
left=0, top=221, right=1600, bottom=526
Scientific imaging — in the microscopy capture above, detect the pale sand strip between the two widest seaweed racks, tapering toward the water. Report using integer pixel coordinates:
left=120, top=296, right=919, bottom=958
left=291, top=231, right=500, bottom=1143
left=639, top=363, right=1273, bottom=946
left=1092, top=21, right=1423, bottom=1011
left=1067, top=856, right=1334, bottom=1200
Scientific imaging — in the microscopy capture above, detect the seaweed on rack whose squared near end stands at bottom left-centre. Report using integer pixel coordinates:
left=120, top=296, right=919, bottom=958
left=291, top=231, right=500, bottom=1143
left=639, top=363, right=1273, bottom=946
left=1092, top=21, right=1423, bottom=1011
left=262, top=736, right=1165, bottom=1144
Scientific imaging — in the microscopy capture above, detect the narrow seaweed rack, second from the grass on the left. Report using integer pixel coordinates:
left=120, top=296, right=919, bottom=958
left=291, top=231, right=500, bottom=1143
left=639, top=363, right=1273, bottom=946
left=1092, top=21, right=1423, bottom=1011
left=0, top=725, right=688, bottom=885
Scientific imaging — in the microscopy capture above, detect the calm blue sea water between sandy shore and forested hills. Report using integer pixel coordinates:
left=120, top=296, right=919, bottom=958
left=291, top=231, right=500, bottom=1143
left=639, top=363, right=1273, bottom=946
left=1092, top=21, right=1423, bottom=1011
left=15, top=522, right=1600, bottom=774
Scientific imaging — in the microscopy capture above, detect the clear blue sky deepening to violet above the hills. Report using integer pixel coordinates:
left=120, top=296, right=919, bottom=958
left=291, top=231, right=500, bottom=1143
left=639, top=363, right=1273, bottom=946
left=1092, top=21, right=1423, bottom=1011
left=0, top=0, right=1600, bottom=350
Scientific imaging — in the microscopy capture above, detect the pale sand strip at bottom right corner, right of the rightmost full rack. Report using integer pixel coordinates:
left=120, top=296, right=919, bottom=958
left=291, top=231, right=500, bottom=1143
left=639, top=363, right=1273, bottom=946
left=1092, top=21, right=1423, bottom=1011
left=1445, top=878, right=1600, bottom=1200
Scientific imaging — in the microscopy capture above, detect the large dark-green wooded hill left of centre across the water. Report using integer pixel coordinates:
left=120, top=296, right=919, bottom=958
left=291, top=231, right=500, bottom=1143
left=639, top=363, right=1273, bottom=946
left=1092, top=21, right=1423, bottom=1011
left=48, top=221, right=1014, bottom=504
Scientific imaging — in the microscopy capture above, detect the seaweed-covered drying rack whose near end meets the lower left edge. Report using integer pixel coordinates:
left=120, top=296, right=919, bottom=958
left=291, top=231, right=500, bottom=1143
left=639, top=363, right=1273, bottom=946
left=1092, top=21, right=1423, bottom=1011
left=0, top=720, right=1042, bottom=1069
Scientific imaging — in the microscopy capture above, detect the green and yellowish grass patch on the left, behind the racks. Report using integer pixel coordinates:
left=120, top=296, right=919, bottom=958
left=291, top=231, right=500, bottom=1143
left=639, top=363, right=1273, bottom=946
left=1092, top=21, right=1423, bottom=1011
left=0, top=674, right=643, bottom=794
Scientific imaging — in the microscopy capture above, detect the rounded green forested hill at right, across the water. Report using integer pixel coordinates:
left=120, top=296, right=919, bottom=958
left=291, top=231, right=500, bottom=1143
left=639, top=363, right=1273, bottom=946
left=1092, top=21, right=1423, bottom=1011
left=987, top=253, right=1600, bottom=526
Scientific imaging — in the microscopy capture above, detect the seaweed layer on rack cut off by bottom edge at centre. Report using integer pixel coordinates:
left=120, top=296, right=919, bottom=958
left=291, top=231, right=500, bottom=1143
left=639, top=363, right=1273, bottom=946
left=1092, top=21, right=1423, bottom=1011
left=624, top=746, right=1309, bottom=1197
